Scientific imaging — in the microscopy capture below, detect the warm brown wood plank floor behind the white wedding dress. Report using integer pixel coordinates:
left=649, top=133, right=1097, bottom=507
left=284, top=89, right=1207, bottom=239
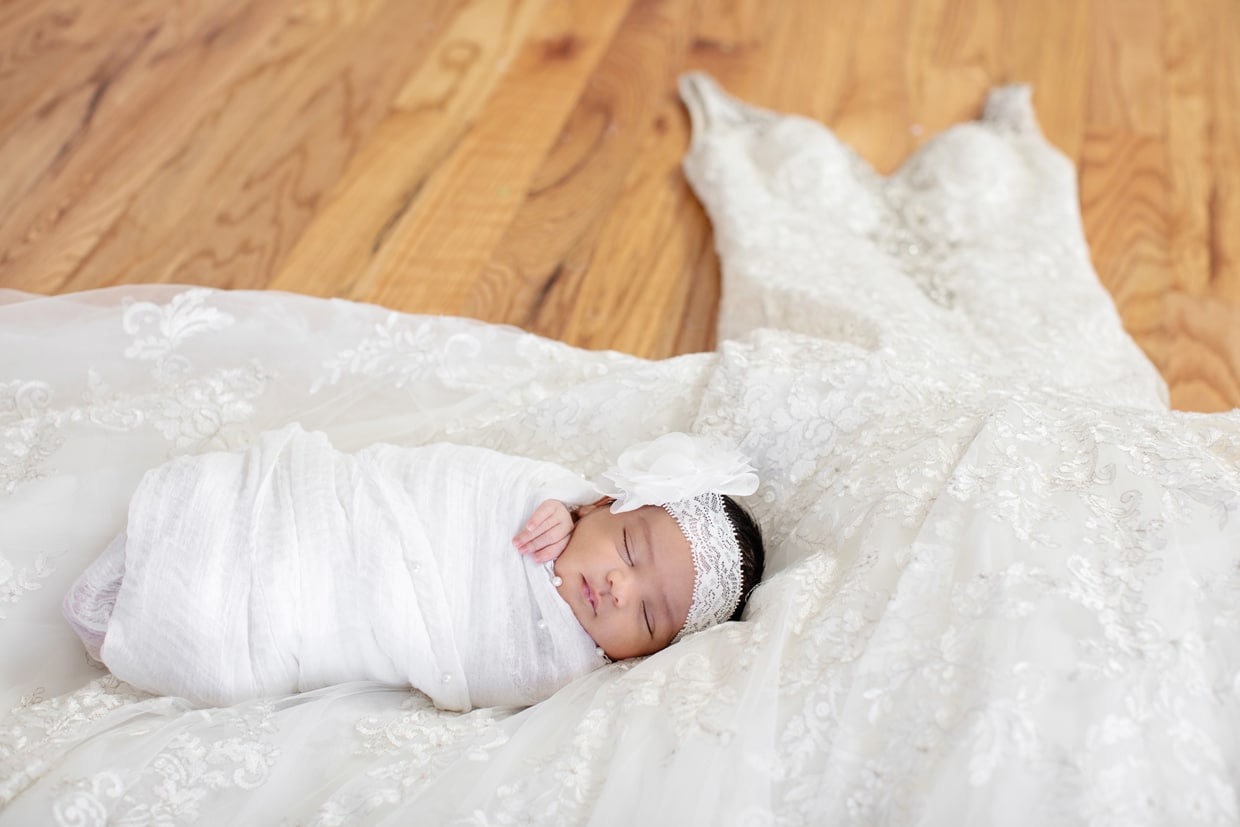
left=0, top=0, right=1240, bottom=410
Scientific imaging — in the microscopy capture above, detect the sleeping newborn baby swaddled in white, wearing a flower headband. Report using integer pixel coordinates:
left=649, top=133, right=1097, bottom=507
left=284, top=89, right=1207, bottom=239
left=64, top=425, right=764, bottom=710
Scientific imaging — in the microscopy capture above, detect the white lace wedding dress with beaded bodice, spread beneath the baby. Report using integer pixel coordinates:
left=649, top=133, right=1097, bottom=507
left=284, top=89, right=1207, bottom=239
left=0, top=76, right=1240, bottom=826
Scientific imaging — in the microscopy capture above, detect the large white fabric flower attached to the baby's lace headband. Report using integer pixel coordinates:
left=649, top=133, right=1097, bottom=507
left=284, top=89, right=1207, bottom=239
left=601, top=433, right=758, bottom=513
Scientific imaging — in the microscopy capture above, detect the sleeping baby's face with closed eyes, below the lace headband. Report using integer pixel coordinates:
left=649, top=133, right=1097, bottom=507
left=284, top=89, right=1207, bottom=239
left=556, top=506, right=694, bottom=661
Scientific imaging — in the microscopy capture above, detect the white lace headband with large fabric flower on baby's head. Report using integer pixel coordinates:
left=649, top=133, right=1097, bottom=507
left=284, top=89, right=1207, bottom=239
left=603, top=433, right=758, bottom=643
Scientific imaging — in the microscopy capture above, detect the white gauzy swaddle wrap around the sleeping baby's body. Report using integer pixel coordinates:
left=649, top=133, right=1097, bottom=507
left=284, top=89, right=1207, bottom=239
left=93, top=425, right=603, bottom=710
